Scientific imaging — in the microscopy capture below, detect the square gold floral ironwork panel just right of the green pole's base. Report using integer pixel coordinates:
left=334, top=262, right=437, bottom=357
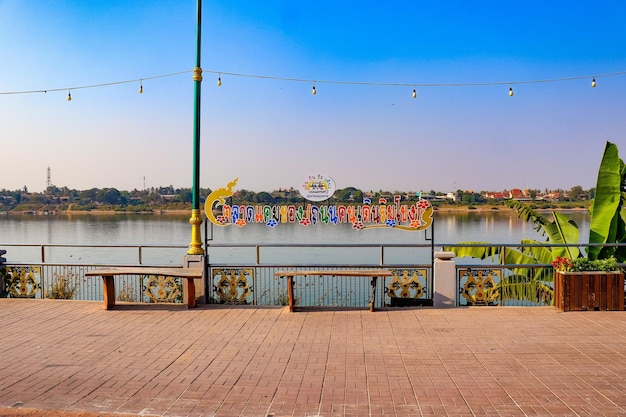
left=213, top=268, right=254, bottom=304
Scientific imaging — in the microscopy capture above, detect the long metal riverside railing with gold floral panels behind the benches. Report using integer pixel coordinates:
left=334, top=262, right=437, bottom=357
left=0, top=243, right=626, bottom=308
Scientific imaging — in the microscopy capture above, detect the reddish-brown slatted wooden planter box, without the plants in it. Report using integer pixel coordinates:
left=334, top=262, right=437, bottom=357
left=554, top=271, right=624, bottom=311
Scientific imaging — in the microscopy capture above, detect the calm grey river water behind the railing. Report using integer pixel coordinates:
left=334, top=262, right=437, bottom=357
left=0, top=211, right=589, bottom=264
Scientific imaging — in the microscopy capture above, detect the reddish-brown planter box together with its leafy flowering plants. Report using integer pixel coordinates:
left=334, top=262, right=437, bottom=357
left=552, top=256, right=624, bottom=311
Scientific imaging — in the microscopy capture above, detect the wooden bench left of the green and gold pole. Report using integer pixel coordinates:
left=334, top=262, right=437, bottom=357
left=85, top=267, right=204, bottom=310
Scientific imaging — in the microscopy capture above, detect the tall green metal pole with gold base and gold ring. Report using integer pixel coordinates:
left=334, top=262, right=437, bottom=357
left=187, top=0, right=204, bottom=255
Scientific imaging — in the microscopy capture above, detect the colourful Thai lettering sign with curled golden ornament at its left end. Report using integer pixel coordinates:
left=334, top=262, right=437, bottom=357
left=204, top=178, right=433, bottom=231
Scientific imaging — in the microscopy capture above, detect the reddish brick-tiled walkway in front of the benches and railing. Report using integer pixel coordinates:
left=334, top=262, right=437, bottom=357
left=0, top=299, right=626, bottom=417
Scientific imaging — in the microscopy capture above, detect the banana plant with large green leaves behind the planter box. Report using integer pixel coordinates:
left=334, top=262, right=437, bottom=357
left=444, top=142, right=626, bottom=303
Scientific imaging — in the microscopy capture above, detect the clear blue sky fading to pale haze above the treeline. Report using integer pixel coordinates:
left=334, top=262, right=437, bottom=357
left=0, top=0, right=626, bottom=191
